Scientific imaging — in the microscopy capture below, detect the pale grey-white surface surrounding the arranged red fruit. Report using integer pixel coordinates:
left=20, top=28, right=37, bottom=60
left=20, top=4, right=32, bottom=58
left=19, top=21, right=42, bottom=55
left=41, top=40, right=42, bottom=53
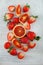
left=0, top=0, right=43, bottom=65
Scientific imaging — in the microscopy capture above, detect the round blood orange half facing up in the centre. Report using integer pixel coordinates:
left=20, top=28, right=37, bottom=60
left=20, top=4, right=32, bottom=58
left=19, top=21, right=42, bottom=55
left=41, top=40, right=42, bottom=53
left=13, top=24, right=26, bottom=38
